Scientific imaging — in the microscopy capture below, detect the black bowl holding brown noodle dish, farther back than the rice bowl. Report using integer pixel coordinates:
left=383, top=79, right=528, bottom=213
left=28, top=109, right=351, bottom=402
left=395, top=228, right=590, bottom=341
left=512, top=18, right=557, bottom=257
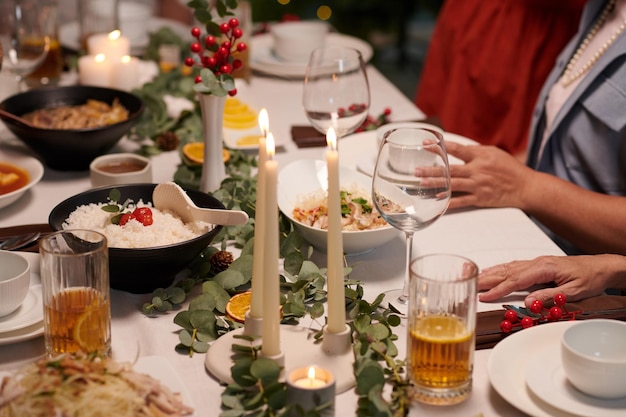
left=0, top=86, right=144, bottom=171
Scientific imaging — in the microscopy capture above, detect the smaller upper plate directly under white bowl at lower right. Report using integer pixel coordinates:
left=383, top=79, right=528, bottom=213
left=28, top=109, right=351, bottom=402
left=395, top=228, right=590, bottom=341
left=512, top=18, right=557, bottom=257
left=526, top=345, right=626, bottom=417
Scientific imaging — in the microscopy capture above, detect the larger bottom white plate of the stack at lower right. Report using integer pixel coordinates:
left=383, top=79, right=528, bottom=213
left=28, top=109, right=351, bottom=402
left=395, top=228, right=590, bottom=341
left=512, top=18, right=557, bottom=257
left=487, top=321, right=576, bottom=417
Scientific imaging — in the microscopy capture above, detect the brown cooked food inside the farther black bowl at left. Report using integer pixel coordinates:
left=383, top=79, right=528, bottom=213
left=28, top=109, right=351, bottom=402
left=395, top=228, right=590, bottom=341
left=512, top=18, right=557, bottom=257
left=23, top=99, right=128, bottom=130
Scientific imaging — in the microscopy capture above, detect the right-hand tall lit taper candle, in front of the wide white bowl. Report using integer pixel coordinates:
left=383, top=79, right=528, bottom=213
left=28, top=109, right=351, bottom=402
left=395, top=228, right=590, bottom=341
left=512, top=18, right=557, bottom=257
left=326, top=127, right=346, bottom=333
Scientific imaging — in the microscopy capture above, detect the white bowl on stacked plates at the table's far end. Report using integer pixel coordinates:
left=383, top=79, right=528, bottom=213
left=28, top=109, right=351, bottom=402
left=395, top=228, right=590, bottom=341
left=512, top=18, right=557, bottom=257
left=271, top=21, right=328, bottom=63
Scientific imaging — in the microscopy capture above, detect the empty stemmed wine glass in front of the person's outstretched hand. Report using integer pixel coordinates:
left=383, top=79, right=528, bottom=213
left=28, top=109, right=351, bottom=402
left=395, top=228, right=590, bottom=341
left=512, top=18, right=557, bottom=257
left=372, top=128, right=451, bottom=314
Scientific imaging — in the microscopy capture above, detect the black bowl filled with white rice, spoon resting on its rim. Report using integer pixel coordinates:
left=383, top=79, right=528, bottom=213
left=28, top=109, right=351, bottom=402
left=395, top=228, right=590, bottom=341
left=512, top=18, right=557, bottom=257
left=48, top=184, right=224, bottom=294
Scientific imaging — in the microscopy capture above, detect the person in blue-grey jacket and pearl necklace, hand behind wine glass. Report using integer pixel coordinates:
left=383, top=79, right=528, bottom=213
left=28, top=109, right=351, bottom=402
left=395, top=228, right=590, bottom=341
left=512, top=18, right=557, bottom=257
left=446, top=0, right=626, bottom=255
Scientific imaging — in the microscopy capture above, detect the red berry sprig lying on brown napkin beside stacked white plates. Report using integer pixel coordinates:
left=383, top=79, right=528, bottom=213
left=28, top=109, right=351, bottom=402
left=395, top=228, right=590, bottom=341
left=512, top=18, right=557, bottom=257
left=500, top=293, right=581, bottom=333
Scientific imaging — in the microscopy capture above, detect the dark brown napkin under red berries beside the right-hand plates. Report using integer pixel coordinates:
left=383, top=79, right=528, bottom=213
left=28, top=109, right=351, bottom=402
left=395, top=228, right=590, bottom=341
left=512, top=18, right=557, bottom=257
left=476, top=295, right=626, bottom=349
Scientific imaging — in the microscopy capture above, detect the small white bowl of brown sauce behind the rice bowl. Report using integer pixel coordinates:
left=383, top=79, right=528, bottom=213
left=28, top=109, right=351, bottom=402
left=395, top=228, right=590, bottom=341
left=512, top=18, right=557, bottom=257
left=89, top=153, right=152, bottom=187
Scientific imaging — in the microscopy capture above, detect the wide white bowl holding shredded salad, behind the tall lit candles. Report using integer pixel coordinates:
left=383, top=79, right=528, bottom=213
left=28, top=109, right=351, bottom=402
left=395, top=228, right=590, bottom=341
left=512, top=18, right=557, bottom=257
left=278, top=159, right=400, bottom=254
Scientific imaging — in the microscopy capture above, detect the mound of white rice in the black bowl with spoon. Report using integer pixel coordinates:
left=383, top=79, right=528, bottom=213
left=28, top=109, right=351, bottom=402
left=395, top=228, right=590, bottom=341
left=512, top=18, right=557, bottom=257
left=62, top=200, right=214, bottom=248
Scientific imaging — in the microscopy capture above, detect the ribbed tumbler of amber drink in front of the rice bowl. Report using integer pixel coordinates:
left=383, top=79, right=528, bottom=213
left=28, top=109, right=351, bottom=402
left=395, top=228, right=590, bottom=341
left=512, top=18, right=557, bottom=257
left=39, top=230, right=111, bottom=356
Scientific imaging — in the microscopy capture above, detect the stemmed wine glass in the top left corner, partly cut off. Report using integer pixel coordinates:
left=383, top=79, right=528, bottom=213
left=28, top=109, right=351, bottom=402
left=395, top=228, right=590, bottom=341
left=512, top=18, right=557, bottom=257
left=0, top=0, right=50, bottom=89
